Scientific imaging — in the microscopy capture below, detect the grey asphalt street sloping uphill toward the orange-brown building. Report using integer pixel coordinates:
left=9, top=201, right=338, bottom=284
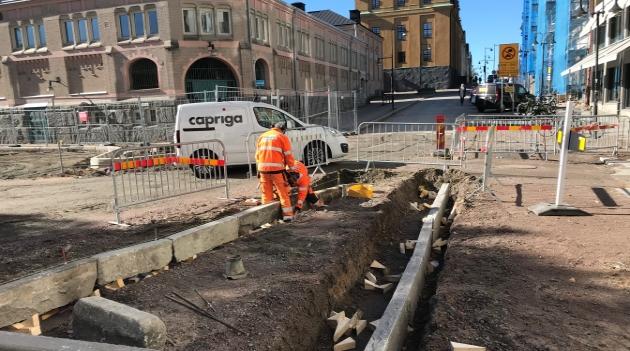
left=386, top=90, right=477, bottom=123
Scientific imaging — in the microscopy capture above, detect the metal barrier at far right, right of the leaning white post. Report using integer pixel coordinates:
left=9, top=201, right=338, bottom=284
left=571, top=115, right=622, bottom=154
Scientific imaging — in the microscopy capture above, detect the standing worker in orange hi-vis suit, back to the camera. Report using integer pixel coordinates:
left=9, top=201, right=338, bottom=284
left=256, top=122, right=295, bottom=221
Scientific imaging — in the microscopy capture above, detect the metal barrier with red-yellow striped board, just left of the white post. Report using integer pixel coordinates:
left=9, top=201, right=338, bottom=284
left=457, top=115, right=559, bottom=157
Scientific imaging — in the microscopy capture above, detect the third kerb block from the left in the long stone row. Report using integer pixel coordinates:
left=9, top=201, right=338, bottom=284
left=168, top=216, right=239, bottom=262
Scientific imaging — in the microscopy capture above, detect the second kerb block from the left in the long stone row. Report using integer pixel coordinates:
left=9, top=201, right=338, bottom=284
left=93, top=239, right=173, bottom=285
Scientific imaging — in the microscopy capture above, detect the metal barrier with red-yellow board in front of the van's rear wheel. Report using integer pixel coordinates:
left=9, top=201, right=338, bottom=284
left=111, top=139, right=229, bottom=224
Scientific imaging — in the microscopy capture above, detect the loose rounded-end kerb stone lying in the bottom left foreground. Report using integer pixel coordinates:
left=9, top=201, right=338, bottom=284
left=72, top=296, right=166, bottom=350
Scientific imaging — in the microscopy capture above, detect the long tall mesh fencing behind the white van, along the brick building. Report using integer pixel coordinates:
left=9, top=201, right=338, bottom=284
left=0, top=86, right=366, bottom=144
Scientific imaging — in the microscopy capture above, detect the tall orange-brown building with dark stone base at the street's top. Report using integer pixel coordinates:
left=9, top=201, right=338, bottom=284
left=356, top=0, right=472, bottom=90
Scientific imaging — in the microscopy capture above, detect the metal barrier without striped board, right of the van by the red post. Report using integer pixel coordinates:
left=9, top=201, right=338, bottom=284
left=356, top=122, right=463, bottom=168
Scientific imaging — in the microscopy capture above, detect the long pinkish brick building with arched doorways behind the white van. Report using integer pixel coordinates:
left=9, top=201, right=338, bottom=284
left=0, top=0, right=383, bottom=106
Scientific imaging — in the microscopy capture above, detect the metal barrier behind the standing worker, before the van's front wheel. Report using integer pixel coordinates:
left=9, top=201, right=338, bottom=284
left=245, top=126, right=331, bottom=178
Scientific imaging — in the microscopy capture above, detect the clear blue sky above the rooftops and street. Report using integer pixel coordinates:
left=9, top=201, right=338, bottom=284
left=304, top=0, right=523, bottom=76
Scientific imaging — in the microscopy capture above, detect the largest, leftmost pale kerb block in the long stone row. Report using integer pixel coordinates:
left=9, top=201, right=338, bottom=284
left=0, top=259, right=97, bottom=327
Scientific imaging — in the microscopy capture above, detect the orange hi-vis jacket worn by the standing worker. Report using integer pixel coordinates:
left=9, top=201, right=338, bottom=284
left=256, top=128, right=295, bottom=173
